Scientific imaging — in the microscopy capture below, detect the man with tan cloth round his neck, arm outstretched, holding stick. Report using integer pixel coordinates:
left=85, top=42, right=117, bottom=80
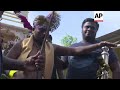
left=7, top=15, right=116, bottom=79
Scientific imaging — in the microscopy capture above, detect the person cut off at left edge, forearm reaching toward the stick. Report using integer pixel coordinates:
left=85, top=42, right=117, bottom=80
left=0, top=11, right=43, bottom=78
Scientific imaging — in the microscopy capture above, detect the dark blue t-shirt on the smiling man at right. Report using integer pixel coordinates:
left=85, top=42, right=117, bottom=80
left=67, top=42, right=117, bottom=79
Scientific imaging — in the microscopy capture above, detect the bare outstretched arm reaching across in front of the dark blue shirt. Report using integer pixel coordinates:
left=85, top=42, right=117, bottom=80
left=54, top=41, right=117, bottom=56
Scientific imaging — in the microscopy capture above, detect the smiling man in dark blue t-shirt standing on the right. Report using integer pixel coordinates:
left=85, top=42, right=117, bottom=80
left=63, top=18, right=120, bottom=79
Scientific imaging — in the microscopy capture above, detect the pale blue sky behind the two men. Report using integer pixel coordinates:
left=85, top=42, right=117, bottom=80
left=1, top=11, right=120, bottom=45
